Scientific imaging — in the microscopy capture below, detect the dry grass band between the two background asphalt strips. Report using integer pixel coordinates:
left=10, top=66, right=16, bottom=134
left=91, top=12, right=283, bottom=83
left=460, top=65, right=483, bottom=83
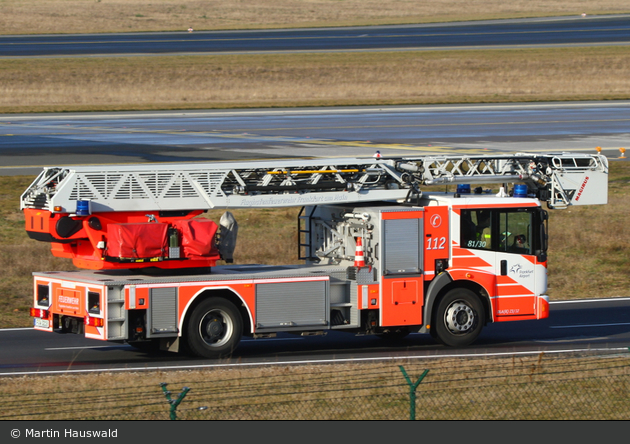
left=0, top=47, right=630, bottom=112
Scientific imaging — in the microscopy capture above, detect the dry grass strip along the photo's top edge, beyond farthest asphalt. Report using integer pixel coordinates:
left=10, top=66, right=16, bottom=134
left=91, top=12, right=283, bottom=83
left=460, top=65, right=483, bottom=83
left=0, top=0, right=630, bottom=34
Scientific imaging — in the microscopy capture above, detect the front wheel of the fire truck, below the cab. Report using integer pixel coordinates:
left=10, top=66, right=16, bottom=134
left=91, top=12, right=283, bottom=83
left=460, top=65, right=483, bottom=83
left=433, top=288, right=485, bottom=347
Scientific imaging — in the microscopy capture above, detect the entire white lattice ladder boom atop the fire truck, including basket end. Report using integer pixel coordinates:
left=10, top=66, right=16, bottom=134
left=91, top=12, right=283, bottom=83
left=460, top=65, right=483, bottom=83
left=21, top=153, right=608, bottom=213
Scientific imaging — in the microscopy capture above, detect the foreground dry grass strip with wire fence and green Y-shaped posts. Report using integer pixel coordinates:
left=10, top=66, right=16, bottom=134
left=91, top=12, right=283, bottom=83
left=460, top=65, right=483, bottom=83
left=0, top=354, right=630, bottom=420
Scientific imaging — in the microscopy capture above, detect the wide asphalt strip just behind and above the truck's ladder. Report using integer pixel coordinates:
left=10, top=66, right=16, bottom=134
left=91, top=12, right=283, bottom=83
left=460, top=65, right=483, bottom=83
left=0, top=101, right=630, bottom=175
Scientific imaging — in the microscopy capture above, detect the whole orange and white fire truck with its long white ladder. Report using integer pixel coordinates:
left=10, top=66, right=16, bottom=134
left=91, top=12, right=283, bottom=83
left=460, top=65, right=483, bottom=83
left=21, top=152, right=608, bottom=358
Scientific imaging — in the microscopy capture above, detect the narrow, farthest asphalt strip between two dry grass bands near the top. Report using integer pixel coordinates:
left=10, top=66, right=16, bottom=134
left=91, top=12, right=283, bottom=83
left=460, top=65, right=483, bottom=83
left=0, top=16, right=630, bottom=57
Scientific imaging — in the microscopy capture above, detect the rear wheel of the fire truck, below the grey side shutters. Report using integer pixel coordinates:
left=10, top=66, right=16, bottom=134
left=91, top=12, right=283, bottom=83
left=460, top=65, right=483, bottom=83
left=185, top=297, right=243, bottom=358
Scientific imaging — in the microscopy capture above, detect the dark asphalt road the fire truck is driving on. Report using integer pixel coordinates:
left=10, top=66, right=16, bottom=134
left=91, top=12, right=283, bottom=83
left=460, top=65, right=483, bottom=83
left=0, top=298, right=630, bottom=375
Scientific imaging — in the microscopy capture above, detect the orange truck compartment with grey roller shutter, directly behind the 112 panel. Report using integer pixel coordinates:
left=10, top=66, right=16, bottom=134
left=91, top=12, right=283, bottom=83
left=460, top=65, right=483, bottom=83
left=380, top=209, right=424, bottom=327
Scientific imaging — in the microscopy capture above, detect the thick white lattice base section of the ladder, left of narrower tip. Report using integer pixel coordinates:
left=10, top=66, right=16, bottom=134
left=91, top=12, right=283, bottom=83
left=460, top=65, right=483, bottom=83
left=22, top=159, right=407, bottom=213
